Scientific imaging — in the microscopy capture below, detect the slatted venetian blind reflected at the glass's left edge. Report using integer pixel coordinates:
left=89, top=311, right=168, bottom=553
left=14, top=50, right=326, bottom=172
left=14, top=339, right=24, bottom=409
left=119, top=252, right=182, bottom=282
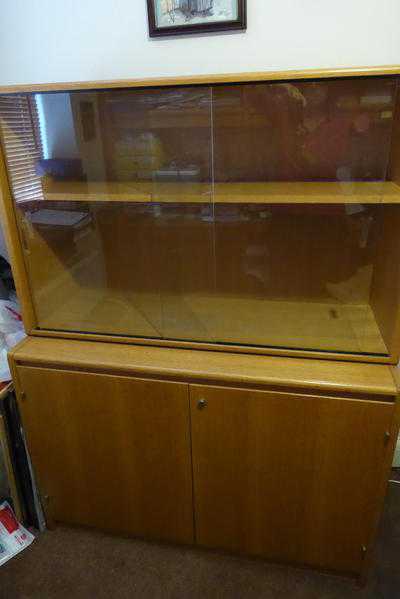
left=0, top=94, right=43, bottom=202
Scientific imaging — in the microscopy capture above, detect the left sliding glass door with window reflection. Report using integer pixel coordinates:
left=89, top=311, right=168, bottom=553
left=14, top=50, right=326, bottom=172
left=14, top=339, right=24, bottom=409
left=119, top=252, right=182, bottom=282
left=2, top=88, right=215, bottom=339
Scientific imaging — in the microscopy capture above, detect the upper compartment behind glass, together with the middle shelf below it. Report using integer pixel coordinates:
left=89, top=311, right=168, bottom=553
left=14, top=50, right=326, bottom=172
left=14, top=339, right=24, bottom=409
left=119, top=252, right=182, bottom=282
left=36, top=79, right=400, bottom=204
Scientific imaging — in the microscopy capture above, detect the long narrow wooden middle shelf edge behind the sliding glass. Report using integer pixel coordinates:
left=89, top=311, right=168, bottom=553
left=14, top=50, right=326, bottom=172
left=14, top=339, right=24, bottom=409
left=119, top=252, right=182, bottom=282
left=39, top=181, right=400, bottom=204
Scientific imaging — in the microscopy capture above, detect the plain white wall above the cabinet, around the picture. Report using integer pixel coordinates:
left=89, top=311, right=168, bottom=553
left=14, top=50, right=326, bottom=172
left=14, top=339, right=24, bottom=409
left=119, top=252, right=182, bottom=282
left=0, top=0, right=400, bottom=85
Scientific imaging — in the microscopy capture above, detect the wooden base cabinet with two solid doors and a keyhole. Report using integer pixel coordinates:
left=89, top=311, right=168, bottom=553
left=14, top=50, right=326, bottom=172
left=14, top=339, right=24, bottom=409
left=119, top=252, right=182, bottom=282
left=11, top=338, right=399, bottom=575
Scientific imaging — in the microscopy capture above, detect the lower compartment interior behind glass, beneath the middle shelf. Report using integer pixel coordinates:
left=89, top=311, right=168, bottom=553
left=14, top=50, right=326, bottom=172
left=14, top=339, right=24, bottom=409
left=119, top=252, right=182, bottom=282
left=18, top=207, right=398, bottom=354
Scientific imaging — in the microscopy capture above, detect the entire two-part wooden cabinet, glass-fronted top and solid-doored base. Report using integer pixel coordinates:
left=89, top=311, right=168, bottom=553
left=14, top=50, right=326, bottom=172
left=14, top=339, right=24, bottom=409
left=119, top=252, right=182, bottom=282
left=0, top=67, right=400, bottom=576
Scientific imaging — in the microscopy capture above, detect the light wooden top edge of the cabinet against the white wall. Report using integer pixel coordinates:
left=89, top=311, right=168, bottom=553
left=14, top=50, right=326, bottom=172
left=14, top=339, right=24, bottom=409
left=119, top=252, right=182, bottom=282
left=0, top=65, right=400, bottom=94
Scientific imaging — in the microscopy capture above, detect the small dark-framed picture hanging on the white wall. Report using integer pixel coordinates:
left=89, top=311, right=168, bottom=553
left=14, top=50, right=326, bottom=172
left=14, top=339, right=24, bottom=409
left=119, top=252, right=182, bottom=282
left=147, top=0, right=246, bottom=37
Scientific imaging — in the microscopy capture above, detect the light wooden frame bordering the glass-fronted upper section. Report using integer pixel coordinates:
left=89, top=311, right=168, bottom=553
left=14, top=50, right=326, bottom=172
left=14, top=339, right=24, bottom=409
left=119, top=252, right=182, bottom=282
left=0, top=66, right=400, bottom=364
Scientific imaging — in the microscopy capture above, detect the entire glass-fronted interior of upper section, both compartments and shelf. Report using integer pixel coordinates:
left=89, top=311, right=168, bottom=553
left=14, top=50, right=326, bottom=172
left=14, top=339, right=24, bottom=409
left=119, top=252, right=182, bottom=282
left=3, top=77, right=400, bottom=356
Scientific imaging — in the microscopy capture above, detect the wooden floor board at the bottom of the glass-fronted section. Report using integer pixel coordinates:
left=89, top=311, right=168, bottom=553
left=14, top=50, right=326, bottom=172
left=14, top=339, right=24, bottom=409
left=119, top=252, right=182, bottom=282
left=36, top=288, right=388, bottom=355
